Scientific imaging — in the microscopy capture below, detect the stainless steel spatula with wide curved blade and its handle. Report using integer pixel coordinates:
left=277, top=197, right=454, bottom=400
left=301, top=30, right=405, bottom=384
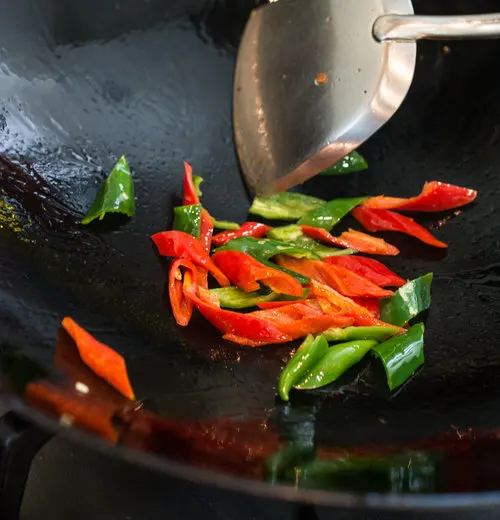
left=234, top=0, right=500, bottom=194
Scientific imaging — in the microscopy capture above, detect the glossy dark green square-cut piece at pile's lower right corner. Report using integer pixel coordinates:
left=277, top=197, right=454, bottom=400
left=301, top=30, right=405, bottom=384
left=373, top=323, right=424, bottom=390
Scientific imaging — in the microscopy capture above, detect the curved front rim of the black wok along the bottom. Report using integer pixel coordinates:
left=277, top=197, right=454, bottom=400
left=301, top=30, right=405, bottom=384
left=5, top=393, right=500, bottom=512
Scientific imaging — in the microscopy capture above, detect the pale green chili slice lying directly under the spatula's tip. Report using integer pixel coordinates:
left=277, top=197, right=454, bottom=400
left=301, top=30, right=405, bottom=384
left=248, top=191, right=326, bottom=220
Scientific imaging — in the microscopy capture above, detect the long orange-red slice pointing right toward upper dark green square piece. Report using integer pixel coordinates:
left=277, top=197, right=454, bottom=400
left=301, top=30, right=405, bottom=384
left=276, top=255, right=393, bottom=298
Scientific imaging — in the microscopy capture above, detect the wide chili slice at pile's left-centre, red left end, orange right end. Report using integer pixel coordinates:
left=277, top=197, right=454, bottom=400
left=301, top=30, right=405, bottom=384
left=212, top=251, right=302, bottom=296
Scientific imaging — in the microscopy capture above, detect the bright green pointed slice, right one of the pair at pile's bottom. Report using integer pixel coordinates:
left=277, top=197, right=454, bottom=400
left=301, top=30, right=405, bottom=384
left=294, top=340, right=377, bottom=390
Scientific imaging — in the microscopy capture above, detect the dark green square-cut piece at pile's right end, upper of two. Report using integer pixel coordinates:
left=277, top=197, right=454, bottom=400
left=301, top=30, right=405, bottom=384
left=380, top=273, right=432, bottom=327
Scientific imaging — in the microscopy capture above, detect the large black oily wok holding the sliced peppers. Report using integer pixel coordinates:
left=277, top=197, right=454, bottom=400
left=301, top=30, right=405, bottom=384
left=0, top=0, right=500, bottom=508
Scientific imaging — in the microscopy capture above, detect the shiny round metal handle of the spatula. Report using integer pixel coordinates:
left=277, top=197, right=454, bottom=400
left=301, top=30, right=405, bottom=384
left=373, top=13, right=500, bottom=42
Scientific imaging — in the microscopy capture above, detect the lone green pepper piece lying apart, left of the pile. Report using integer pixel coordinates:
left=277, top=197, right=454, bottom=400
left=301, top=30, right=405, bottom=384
left=82, top=155, right=135, bottom=224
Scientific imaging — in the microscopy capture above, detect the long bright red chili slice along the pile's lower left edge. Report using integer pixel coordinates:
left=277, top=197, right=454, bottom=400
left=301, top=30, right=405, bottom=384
left=185, top=290, right=292, bottom=346
